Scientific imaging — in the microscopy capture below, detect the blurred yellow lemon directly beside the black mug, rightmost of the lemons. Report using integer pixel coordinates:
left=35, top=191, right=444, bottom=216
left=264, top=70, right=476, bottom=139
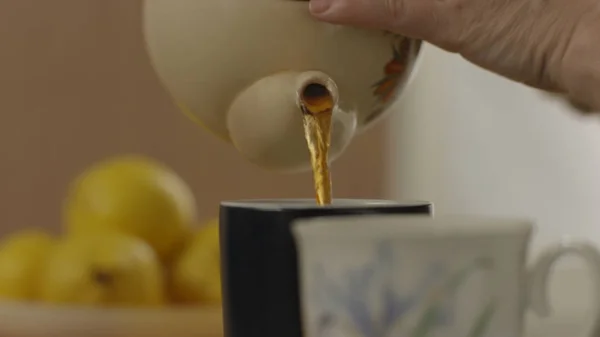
left=170, top=219, right=222, bottom=304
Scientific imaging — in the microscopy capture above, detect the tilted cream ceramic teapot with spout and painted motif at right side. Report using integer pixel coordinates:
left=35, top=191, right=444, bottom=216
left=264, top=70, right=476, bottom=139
left=143, top=0, right=421, bottom=172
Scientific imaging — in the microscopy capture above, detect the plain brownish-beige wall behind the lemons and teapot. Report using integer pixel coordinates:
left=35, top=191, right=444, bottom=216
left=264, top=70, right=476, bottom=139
left=0, top=0, right=385, bottom=234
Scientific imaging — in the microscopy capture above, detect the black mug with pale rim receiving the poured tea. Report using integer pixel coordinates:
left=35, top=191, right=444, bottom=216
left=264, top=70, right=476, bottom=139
left=219, top=199, right=433, bottom=337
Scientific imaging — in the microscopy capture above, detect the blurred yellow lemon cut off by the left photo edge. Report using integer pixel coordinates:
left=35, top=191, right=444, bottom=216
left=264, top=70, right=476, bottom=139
left=0, top=230, right=53, bottom=300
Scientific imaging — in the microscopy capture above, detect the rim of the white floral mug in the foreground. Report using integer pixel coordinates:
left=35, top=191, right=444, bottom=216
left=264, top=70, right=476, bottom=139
left=292, top=214, right=535, bottom=241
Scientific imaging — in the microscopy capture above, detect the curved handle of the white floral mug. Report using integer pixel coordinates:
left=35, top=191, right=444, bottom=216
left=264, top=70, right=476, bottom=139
left=527, top=242, right=600, bottom=337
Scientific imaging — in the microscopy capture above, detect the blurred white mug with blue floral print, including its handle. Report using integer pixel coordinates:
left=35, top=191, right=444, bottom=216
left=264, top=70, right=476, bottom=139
left=293, top=215, right=600, bottom=337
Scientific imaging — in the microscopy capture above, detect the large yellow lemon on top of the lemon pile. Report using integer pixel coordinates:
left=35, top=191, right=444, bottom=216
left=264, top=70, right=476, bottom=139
left=65, top=156, right=196, bottom=259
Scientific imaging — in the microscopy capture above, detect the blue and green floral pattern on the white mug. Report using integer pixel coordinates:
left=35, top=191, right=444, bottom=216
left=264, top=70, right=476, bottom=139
left=312, top=241, right=494, bottom=337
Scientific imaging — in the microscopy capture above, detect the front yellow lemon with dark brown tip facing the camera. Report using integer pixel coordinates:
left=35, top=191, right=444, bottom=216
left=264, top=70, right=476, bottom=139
left=40, top=231, right=165, bottom=307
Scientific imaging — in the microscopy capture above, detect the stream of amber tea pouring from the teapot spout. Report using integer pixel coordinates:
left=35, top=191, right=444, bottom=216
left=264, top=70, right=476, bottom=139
left=300, top=83, right=334, bottom=206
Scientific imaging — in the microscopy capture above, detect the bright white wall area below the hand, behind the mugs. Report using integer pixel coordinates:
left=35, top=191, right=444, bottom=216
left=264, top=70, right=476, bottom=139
left=389, top=46, right=600, bottom=255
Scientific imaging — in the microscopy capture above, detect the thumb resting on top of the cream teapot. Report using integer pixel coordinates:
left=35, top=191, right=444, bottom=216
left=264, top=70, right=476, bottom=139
left=310, top=0, right=439, bottom=38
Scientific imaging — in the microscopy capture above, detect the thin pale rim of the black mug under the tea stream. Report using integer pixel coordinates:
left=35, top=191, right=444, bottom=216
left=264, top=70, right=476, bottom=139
left=221, top=198, right=432, bottom=210
